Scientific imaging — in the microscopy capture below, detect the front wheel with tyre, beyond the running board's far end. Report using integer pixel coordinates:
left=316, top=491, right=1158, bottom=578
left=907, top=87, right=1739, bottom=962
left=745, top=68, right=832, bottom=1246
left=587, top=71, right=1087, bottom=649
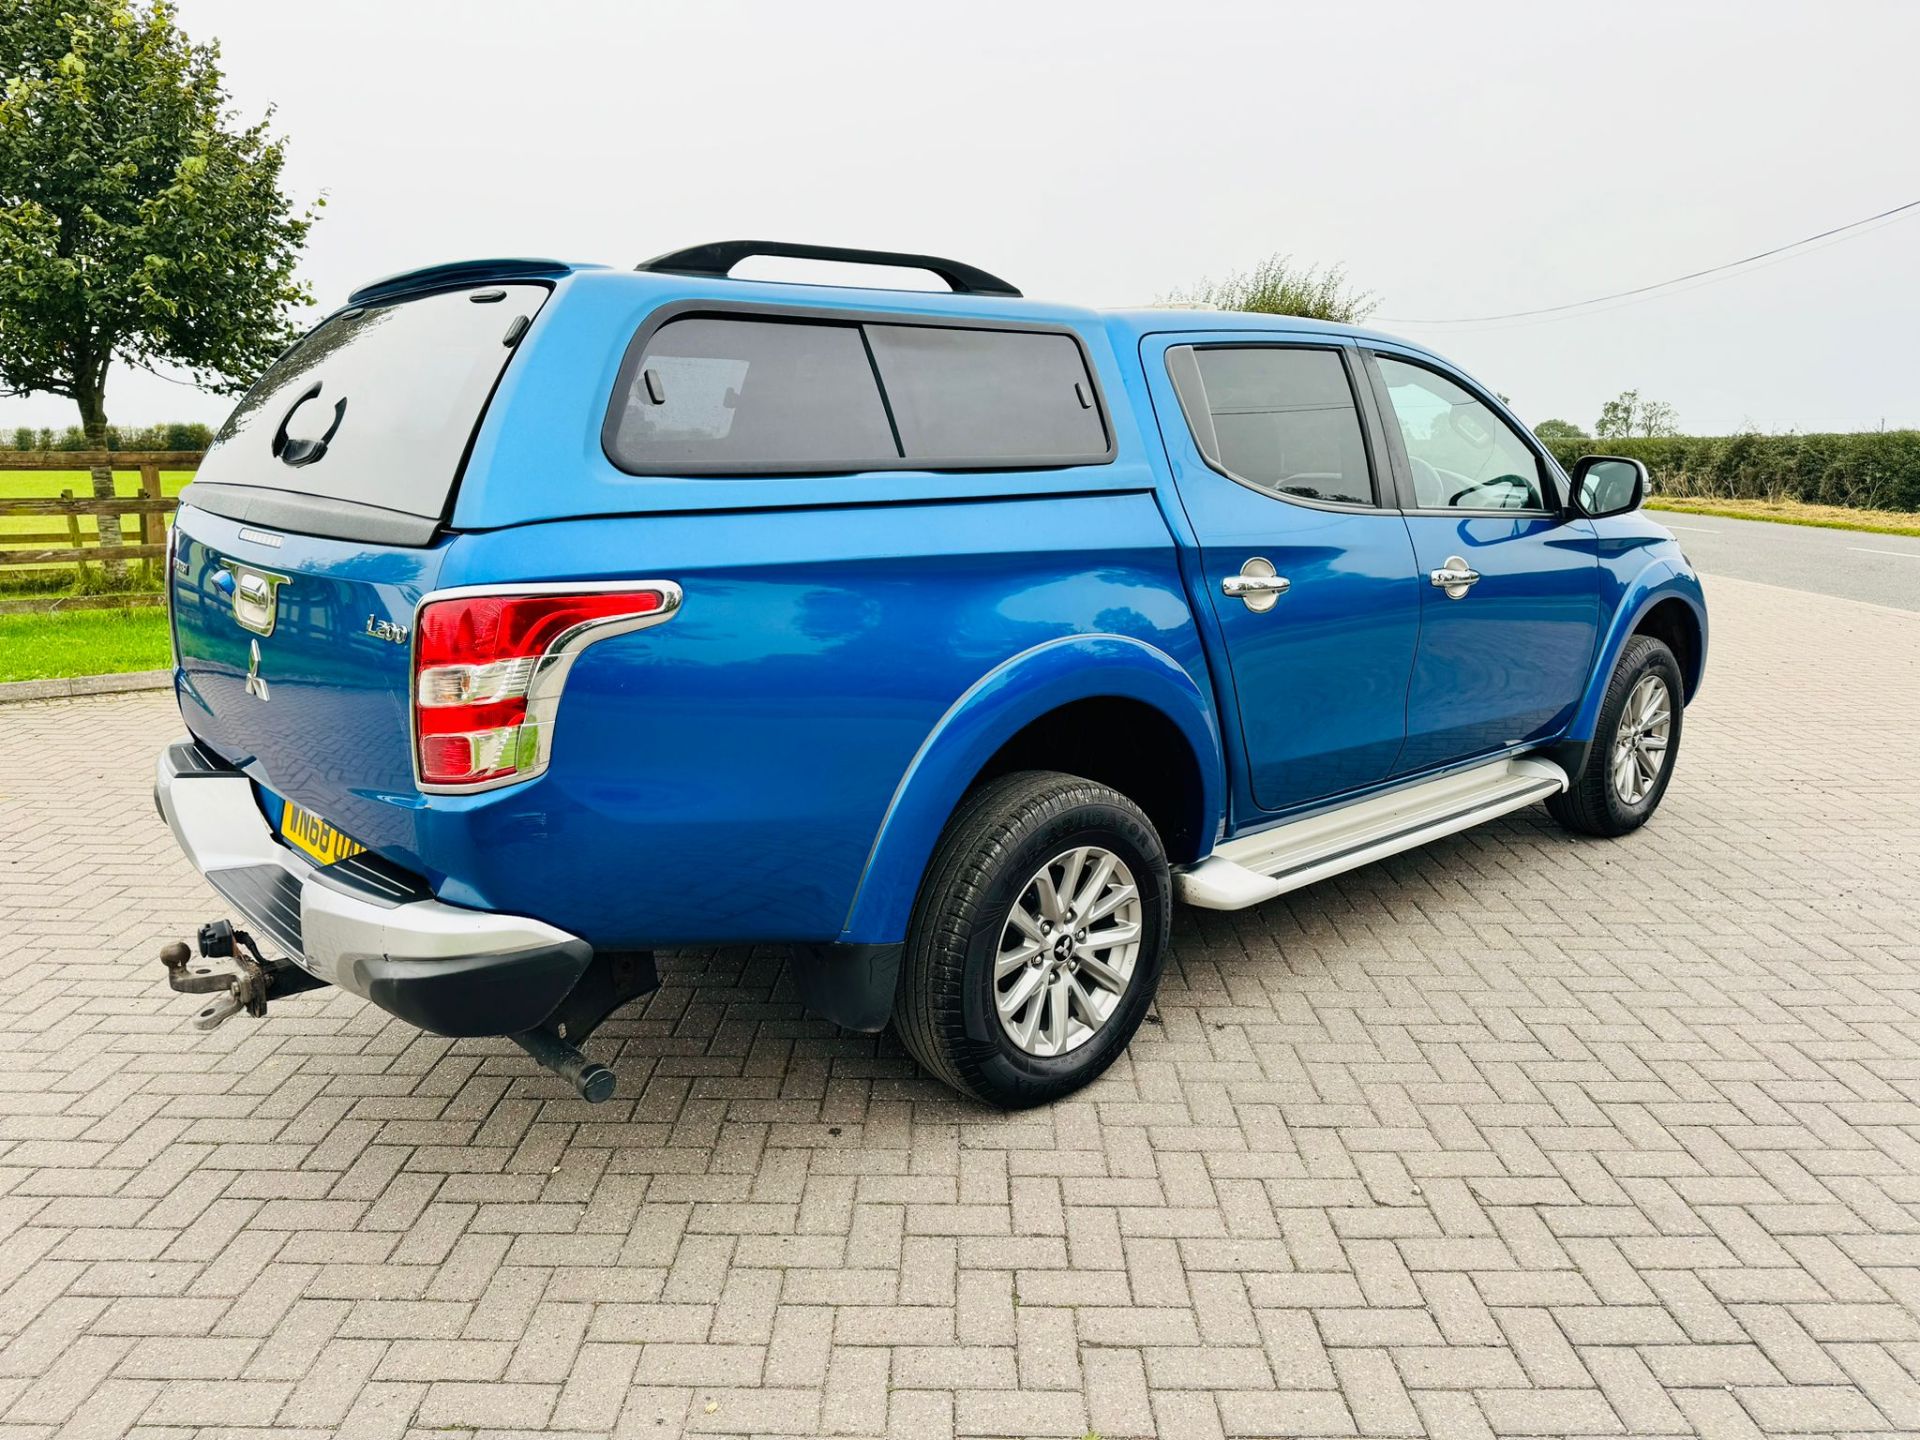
left=1548, top=636, right=1686, bottom=837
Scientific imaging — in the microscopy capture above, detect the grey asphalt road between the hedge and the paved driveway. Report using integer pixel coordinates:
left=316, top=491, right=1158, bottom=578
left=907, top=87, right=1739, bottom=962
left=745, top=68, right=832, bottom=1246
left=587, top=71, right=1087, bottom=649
left=1647, top=511, right=1920, bottom=611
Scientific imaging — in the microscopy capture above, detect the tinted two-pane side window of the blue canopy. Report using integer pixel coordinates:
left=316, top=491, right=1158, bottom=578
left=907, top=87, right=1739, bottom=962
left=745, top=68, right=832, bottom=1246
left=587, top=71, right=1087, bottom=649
left=603, top=315, right=1112, bottom=476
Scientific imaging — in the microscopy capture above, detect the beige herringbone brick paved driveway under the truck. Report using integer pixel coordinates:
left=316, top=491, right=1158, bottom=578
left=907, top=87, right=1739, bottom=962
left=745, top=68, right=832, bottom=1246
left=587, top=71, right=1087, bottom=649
left=0, top=580, right=1920, bottom=1440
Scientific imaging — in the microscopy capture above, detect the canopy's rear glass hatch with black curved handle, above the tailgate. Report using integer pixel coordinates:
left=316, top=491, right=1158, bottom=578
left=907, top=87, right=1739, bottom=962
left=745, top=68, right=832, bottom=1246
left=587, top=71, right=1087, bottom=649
left=196, top=284, right=547, bottom=518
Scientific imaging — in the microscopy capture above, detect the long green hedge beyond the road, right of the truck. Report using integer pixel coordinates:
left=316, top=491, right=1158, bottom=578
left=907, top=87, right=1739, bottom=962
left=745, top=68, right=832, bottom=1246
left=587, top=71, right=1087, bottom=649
left=1548, top=430, right=1920, bottom=511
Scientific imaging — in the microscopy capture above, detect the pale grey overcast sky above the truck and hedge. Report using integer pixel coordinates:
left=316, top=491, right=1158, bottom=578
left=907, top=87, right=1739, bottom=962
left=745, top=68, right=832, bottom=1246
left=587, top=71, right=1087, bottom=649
left=0, top=0, right=1920, bottom=432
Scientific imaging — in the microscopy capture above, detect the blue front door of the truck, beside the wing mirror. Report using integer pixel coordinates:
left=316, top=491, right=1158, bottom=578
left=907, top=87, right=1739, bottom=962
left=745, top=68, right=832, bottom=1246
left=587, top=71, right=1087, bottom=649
left=1367, top=351, right=1599, bottom=774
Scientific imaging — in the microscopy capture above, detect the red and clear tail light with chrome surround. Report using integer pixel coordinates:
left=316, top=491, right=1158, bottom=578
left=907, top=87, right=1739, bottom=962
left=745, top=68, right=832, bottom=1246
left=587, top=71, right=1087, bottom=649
left=413, top=580, right=680, bottom=791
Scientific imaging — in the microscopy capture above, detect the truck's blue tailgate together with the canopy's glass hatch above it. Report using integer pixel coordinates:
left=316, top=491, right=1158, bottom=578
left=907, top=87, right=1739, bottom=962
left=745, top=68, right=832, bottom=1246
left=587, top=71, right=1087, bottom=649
left=169, top=284, right=549, bottom=845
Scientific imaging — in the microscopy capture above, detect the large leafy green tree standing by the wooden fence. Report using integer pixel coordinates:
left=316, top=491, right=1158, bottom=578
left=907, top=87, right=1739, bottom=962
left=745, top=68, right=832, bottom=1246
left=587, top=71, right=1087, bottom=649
left=0, top=0, right=312, bottom=574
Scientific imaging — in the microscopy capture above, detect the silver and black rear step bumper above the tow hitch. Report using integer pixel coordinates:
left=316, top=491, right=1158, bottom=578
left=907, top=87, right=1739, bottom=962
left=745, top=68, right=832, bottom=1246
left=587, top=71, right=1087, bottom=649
left=154, top=739, right=593, bottom=1035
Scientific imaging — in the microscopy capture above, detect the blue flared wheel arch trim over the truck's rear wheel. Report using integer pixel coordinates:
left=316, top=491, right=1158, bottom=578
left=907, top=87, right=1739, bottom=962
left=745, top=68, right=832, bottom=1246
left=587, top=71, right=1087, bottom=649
left=841, top=636, right=1225, bottom=943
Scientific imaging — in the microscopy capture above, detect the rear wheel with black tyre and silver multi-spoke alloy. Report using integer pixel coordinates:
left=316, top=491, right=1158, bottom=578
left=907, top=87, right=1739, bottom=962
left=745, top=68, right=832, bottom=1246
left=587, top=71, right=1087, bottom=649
left=893, top=772, right=1173, bottom=1108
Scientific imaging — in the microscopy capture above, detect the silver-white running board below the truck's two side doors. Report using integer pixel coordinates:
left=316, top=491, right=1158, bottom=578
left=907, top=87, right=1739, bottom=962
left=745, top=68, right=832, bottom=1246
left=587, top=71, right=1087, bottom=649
left=1173, top=755, right=1567, bottom=910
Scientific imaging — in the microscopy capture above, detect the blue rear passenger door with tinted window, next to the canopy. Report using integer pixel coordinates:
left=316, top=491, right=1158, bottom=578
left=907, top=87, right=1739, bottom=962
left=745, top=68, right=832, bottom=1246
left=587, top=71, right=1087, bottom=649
left=1142, top=332, right=1421, bottom=810
